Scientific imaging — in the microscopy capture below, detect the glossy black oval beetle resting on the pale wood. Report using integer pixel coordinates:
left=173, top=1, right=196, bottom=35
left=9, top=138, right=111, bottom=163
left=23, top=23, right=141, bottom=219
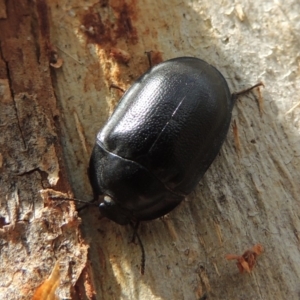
left=89, top=57, right=262, bottom=225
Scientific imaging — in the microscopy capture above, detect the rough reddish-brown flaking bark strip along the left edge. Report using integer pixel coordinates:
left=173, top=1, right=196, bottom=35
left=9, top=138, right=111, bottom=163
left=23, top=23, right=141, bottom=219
left=0, top=1, right=87, bottom=299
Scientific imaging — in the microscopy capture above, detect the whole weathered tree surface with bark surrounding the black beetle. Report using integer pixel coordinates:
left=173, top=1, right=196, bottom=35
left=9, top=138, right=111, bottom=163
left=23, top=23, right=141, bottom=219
left=0, top=0, right=300, bottom=299
